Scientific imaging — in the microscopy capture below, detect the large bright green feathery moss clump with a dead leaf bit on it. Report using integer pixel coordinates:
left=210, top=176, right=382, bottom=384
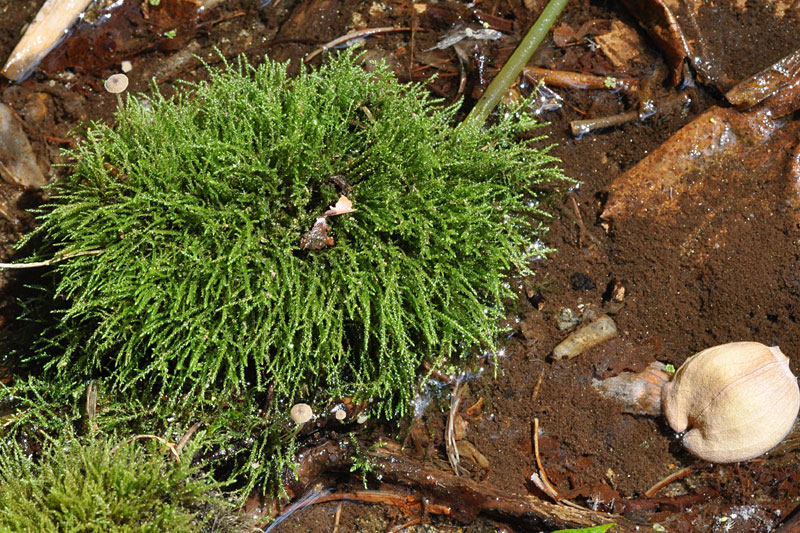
left=21, top=54, right=564, bottom=417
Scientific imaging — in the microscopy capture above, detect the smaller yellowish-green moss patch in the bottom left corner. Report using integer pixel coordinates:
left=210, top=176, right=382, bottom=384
left=0, top=438, right=234, bottom=532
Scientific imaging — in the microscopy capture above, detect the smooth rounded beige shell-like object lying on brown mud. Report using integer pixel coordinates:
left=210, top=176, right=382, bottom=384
left=662, top=342, right=800, bottom=463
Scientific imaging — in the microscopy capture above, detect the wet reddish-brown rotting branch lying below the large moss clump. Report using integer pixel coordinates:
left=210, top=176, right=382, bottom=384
left=276, top=441, right=648, bottom=532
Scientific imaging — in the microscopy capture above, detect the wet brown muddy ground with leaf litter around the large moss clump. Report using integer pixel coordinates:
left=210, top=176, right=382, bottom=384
left=0, top=0, right=800, bottom=532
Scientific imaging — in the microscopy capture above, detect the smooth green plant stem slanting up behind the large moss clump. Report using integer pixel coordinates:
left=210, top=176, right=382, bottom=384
left=464, top=0, right=567, bottom=126
